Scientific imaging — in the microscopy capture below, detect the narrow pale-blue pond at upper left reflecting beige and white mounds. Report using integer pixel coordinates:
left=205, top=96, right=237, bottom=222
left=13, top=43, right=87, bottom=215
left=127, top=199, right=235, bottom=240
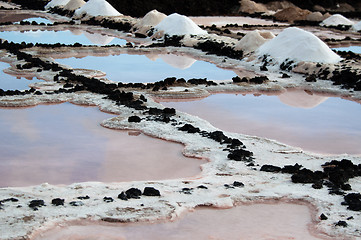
left=0, top=30, right=127, bottom=45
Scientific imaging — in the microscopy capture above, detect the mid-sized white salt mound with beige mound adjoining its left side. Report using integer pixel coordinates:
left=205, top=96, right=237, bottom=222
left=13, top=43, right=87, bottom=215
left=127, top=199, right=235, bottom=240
left=154, top=13, right=207, bottom=36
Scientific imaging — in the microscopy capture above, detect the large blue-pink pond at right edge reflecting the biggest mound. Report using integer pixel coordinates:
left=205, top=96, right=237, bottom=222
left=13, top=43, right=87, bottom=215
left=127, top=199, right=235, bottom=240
left=163, top=90, right=361, bottom=154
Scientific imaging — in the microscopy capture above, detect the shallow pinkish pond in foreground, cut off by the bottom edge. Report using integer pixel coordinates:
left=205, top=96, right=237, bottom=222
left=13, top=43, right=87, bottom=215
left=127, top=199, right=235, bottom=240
left=33, top=203, right=330, bottom=240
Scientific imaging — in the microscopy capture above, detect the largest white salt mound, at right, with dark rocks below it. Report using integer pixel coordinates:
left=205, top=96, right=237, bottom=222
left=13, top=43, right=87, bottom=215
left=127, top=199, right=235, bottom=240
left=257, top=27, right=341, bottom=63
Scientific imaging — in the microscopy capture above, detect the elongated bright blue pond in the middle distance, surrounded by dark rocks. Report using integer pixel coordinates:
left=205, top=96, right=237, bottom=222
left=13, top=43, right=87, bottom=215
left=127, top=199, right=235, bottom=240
left=56, top=54, right=235, bottom=83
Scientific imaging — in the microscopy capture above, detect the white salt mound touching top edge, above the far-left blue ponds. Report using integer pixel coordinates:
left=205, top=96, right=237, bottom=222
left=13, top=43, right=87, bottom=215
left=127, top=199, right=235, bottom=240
left=75, top=0, right=122, bottom=17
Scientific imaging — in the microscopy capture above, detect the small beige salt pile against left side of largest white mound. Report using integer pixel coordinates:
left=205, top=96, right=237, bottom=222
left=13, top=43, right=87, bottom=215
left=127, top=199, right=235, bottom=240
left=234, top=30, right=275, bottom=52
